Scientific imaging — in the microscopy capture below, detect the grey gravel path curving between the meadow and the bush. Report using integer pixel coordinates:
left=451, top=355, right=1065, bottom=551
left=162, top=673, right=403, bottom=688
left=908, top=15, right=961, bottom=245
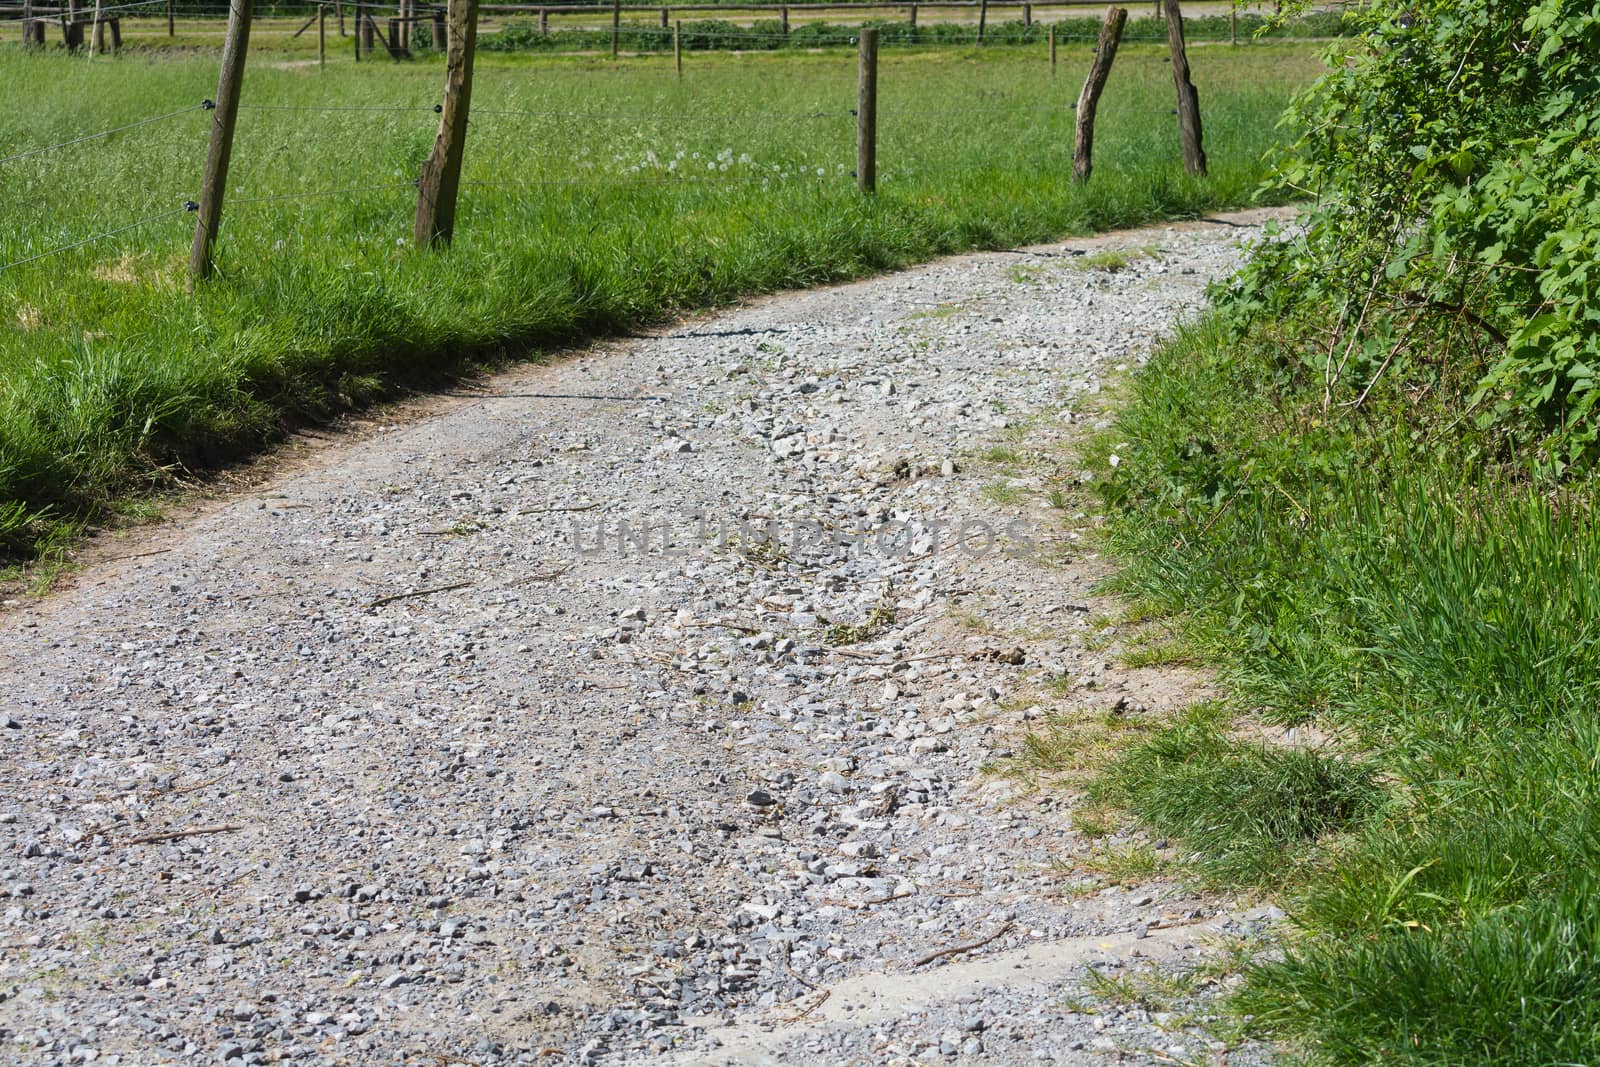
left=0, top=214, right=1272, bottom=1065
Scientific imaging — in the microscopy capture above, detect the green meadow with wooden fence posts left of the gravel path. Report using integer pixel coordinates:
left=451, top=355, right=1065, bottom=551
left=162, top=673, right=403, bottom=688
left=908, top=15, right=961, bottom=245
left=0, top=45, right=1318, bottom=553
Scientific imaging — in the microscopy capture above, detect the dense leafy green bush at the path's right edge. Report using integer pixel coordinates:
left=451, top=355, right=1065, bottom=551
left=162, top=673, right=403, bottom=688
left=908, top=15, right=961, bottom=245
left=1221, top=0, right=1600, bottom=475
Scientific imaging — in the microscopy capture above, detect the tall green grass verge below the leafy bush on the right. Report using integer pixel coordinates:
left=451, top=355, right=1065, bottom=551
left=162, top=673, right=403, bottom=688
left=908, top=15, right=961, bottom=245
left=1098, top=318, right=1600, bottom=1064
